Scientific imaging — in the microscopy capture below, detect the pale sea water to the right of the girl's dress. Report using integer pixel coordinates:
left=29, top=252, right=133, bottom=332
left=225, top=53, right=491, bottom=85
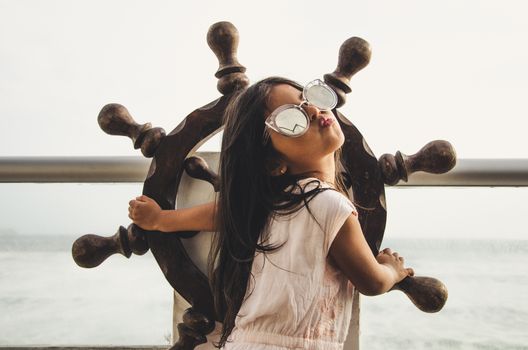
left=360, top=239, right=528, bottom=350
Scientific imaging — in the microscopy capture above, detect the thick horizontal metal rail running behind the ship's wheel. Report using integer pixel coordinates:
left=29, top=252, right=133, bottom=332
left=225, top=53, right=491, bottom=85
left=0, top=152, right=528, bottom=187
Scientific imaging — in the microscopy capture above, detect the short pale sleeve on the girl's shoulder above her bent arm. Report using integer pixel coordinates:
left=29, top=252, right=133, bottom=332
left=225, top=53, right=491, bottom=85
left=308, top=189, right=358, bottom=255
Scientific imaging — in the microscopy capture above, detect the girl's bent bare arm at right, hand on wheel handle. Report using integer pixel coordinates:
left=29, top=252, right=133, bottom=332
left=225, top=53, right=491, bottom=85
left=329, top=214, right=414, bottom=295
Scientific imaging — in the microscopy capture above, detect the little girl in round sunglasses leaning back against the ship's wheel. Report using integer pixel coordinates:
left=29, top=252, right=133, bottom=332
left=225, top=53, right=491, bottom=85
left=129, top=77, right=414, bottom=350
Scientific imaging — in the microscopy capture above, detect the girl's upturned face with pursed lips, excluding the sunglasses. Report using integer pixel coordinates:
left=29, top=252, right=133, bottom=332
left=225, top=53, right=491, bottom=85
left=262, top=84, right=345, bottom=170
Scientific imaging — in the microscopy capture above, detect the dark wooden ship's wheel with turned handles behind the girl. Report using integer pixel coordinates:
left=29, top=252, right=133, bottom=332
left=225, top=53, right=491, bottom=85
left=72, top=22, right=456, bottom=349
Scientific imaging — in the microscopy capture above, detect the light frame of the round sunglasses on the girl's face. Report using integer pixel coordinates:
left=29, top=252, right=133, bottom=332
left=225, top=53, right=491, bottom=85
left=263, top=79, right=337, bottom=142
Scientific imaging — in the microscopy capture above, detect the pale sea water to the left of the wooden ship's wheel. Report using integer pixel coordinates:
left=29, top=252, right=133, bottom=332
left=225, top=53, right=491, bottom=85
left=0, top=235, right=172, bottom=345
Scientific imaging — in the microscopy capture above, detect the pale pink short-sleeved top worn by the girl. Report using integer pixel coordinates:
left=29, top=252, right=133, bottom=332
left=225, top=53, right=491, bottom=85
left=224, top=178, right=357, bottom=350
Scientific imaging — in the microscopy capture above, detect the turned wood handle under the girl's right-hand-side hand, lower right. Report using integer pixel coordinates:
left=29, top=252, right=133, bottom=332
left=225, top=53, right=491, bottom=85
left=391, top=276, right=448, bottom=313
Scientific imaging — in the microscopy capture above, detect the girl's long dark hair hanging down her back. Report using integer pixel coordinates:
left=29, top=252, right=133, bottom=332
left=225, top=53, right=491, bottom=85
left=209, top=77, right=346, bottom=348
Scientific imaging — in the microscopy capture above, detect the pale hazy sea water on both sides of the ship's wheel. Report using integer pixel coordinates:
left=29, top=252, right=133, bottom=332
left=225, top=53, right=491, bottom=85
left=0, top=235, right=528, bottom=350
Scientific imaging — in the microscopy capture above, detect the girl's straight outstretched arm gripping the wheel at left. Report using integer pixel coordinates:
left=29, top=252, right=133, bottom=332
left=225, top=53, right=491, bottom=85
left=128, top=195, right=216, bottom=232
